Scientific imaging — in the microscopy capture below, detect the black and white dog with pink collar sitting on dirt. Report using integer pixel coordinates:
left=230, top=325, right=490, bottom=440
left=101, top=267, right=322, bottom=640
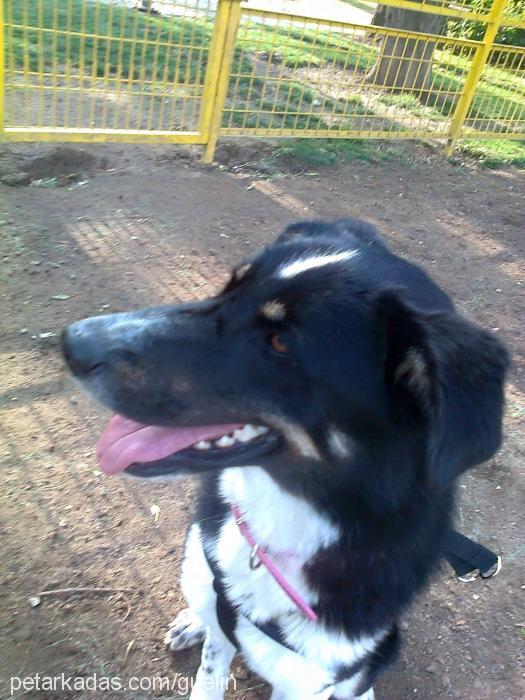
left=63, top=219, right=508, bottom=700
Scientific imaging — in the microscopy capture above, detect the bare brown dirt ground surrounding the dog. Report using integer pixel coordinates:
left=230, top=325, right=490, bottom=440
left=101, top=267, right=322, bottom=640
left=0, top=139, right=525, bottom=700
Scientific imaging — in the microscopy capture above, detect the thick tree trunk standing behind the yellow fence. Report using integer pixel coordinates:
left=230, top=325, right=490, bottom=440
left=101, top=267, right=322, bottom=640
left=367, top=5, right=446, bottom=92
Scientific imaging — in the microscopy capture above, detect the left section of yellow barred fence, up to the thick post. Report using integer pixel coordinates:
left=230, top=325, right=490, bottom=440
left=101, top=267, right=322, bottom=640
left=0, top=0, right=234, bottom=144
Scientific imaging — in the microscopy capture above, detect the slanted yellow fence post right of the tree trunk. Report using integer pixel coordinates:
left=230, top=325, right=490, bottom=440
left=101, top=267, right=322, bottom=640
left=445, top=0, right=508, bottom=156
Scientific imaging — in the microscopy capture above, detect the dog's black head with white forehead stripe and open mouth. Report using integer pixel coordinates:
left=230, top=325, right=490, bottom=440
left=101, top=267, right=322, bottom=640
left=63, top=221, right=507, bottom=498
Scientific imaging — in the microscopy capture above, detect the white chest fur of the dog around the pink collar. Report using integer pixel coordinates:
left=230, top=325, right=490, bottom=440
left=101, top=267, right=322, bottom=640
left=206, top=467, right=382, bottom=697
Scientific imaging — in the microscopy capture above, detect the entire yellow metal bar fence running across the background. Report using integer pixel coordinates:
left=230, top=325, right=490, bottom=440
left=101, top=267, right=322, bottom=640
left=0, top=0, right=525, bottom=160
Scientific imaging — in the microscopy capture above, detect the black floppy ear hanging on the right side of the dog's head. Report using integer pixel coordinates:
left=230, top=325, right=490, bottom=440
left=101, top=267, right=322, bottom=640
left=375, top=291, right=509, bottom=490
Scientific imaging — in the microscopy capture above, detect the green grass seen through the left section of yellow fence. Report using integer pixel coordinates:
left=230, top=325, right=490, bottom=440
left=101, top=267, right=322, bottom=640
left=6, top=0, right=212, bottom=83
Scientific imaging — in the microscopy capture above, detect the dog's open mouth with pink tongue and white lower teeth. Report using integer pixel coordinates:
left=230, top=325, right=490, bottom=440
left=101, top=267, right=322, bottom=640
left=97, top=415, right=281, bottom=477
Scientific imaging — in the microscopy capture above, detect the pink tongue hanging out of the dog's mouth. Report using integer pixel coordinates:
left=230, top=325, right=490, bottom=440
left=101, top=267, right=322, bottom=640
left=97, top=415, right=241, bottom=474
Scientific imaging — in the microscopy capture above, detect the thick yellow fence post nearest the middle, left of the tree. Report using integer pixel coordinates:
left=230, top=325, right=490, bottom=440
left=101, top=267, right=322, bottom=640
left=199, top=0, right=241, bottom=163
